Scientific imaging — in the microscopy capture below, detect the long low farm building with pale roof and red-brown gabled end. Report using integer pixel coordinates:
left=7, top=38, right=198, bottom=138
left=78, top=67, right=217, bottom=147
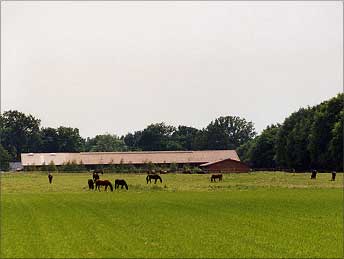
left=21, top=150, right=249, bottom=172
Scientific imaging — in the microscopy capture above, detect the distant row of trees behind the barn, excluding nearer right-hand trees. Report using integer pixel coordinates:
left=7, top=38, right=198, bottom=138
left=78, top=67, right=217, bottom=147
left=0, top=110, right=256, bottom=170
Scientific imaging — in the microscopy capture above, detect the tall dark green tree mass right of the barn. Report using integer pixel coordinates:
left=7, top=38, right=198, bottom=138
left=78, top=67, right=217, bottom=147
left=237, top=94, right=344, bottom=171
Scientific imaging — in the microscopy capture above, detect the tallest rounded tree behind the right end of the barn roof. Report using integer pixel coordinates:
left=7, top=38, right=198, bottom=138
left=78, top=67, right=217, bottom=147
left=206, top=116, right=256, bottom=149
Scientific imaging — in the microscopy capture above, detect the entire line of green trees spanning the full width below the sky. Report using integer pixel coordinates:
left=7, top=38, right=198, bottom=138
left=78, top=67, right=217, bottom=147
left=0, top=94, right=344, bottom=171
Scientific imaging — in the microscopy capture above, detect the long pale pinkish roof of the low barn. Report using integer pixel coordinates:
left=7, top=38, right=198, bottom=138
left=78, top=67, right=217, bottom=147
left=21, top=150, right=240, bottom=166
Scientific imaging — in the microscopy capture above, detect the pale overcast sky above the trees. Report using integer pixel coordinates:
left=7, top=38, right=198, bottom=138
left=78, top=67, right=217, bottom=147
left=1, top=1, right=343, bottom=138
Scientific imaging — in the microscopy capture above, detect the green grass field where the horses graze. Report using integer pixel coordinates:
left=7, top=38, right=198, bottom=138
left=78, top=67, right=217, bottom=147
left=0, top=172, right=344, bottom=258
